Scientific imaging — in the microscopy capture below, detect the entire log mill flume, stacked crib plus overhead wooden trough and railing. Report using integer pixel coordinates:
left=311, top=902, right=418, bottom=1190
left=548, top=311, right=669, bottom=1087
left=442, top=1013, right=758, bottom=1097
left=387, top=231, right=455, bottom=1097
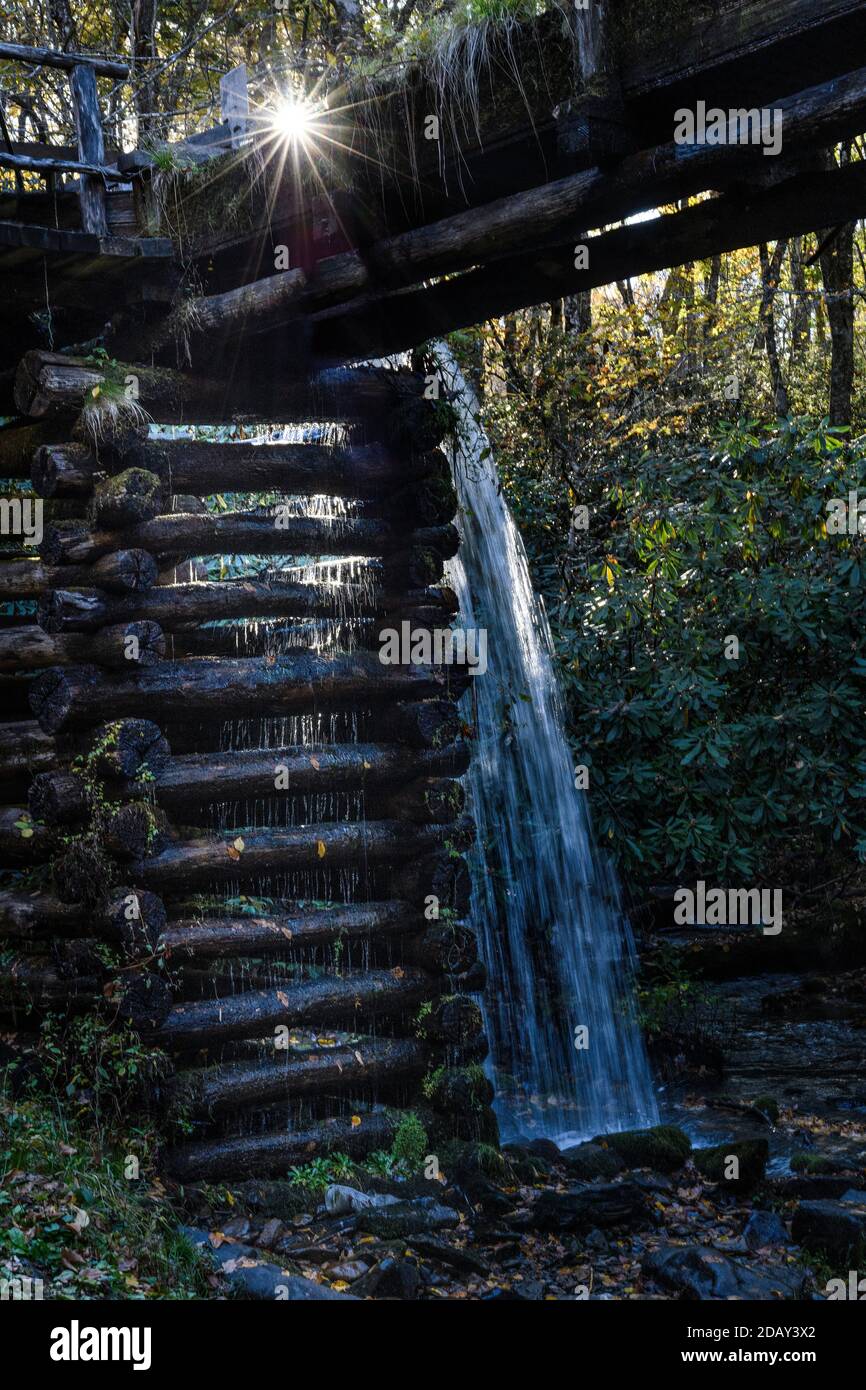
left=0, top=0, right=866, bottom=1180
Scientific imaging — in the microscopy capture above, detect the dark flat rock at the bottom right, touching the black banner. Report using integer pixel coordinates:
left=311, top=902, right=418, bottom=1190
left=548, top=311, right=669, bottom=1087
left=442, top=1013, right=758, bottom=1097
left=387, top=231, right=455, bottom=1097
left=642, top=1245, right=806, bottom=1301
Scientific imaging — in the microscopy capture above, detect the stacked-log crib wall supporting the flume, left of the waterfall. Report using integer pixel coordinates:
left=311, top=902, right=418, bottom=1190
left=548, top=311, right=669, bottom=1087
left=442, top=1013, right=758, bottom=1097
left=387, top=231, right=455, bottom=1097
left=0, top=336, right=493, bottom=1180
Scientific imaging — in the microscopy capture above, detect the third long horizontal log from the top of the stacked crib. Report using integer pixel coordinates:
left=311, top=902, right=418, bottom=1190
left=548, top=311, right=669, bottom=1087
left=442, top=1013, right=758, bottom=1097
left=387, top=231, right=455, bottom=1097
left=39, top=507, right=460, bottom=564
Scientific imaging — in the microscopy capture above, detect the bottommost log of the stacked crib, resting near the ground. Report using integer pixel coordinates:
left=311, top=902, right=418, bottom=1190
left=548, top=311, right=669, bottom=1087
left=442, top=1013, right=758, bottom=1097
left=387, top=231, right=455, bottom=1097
left=165, top=1112, right=399, bottom=1183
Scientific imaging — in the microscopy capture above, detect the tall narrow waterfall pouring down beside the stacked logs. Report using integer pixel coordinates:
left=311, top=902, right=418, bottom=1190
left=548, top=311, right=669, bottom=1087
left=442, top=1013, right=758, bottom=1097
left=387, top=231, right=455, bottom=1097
left=435, top=345, right=657, bottom=1141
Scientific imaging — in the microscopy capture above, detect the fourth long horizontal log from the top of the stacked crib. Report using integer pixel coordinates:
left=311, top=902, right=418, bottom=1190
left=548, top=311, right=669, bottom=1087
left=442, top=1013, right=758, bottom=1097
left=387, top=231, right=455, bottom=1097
left=36, top=580, right=457, bottom=632
